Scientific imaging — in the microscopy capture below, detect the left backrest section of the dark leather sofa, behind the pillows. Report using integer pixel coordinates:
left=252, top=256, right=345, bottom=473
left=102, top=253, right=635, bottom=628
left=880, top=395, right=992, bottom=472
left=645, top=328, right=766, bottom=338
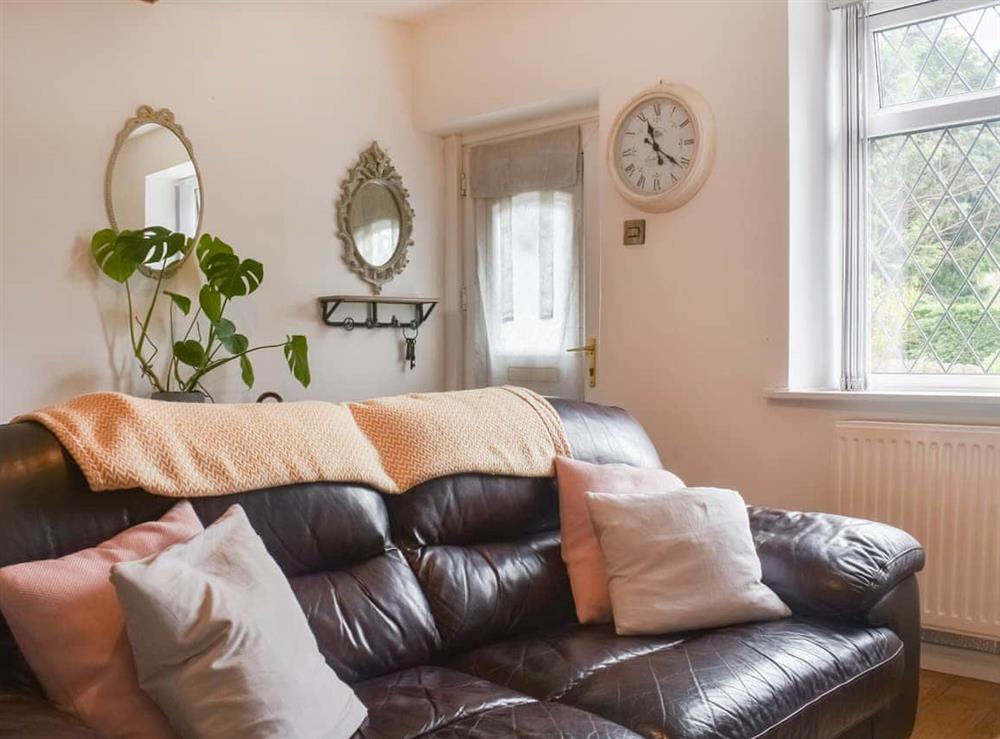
left=0, top=424, right=440, bottom=683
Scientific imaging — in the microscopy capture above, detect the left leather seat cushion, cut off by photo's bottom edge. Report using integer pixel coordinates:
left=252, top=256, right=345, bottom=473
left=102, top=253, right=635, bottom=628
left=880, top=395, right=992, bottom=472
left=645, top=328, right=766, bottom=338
left=354, top=666, right=635, bottom=739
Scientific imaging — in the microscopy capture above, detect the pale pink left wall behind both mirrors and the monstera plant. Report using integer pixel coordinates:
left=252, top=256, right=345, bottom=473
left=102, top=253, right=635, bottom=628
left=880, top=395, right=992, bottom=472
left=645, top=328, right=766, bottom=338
left=0, top=0, right=443, bottom=420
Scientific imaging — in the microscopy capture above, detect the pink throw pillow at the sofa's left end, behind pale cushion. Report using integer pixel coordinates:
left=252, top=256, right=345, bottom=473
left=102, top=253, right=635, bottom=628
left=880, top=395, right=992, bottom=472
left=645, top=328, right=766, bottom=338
left=0, top=501, right=203, bottom=739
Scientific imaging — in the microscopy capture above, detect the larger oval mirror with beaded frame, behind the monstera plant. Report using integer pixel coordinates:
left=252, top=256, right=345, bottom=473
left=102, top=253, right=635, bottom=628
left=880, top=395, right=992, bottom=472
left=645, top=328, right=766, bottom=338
left=104, top=105, right=204, bottom=277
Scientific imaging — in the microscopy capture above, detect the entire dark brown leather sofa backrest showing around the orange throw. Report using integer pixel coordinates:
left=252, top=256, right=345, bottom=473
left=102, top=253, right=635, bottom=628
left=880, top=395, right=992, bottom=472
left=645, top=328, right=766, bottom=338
left=0, top=400, right=659, bottom=682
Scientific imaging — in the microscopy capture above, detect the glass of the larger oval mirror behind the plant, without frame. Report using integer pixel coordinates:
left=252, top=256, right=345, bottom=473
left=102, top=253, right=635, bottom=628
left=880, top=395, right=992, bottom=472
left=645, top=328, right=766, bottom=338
left=110, top=123, right=201, bottom=269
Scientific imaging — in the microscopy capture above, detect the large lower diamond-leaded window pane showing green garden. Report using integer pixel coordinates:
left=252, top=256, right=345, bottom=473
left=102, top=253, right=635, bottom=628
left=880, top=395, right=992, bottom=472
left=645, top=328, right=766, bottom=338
left=868, top=123, right=1000, bottom=375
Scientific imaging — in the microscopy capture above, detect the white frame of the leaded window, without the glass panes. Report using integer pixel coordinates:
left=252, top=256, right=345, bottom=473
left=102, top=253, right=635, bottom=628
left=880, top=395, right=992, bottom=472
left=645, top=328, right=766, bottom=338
left=856, top=0, right=1000, bottom=393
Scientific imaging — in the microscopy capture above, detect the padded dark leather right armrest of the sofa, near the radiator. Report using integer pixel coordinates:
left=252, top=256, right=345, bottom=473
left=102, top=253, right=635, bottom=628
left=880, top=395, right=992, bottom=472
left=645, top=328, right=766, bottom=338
left=747, top=506, right=924, bottom=617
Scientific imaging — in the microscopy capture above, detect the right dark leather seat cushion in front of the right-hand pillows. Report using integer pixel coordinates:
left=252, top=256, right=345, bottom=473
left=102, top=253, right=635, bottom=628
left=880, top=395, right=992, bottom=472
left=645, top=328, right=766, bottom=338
left=449, top=618, right=903, bottom=739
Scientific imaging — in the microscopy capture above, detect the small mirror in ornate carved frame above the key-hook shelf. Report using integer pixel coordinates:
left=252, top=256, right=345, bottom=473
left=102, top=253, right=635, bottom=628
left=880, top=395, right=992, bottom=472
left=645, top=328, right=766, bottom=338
left=337, top=143, right=413, bottom=295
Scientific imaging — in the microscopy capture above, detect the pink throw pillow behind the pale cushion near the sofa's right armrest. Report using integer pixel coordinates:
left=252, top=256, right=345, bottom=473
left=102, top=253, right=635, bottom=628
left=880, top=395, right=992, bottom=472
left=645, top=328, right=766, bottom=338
left=556, top=457, right=684, bottom=624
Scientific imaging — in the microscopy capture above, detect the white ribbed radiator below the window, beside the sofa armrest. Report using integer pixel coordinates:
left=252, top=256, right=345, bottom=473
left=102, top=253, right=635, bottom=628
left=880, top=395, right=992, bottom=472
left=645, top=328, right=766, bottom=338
left=834, top=421, right=1000, bottom=640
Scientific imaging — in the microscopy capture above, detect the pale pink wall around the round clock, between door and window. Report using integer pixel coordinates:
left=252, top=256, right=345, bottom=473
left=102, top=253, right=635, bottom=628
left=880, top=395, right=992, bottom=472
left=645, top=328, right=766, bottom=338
left=414, top=0, right=996, bottom=509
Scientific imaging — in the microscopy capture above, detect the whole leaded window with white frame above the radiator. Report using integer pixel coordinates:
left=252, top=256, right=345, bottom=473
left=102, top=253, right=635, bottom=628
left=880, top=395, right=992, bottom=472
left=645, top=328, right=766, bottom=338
left=864, top=0, right=1000, bottom=390
